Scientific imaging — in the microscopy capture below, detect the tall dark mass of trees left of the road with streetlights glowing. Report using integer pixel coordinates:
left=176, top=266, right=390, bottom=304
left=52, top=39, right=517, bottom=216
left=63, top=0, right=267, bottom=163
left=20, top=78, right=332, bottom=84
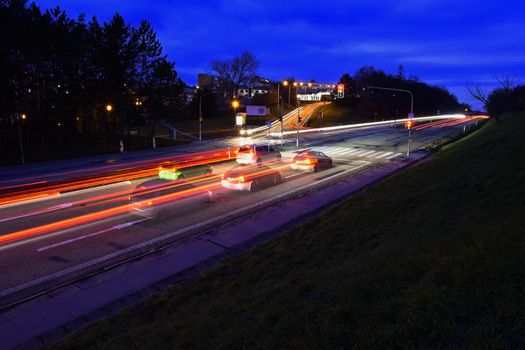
left=0, top=0, right=184, bottom=163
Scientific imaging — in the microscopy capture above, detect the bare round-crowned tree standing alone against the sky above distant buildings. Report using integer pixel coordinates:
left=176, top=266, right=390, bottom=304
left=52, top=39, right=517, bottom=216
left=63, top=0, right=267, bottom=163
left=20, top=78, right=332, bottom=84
left=211, top=51, right=259, bottom=95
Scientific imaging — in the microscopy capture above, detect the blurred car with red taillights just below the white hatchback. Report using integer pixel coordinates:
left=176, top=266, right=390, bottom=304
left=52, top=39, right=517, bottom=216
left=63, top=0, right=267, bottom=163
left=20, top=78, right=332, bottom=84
left=221, top=165, right=282, bottom=192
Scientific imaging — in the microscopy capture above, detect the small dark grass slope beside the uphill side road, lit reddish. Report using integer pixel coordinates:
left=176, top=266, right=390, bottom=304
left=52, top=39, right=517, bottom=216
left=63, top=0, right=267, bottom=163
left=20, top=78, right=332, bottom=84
left=307, top=103, right=370, bottom=128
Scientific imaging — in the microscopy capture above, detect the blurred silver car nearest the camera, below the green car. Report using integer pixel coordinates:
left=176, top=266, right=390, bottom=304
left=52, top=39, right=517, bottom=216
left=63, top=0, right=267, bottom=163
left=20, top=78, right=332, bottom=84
left=129, top=179, right=204, bottom=218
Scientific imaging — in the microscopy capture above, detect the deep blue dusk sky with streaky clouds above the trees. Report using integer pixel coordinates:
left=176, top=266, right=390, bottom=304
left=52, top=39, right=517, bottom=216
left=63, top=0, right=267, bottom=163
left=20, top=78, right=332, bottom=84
left=36, top=0, right=525, bottom=109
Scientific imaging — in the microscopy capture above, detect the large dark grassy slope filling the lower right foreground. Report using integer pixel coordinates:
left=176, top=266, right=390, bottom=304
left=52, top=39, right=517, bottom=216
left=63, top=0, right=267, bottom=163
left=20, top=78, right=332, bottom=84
left=53, top=114, right=525, bottom=349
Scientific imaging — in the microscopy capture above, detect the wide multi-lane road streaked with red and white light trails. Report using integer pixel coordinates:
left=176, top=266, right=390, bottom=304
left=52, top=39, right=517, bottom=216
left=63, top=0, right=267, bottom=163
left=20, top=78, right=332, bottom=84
left=0, top=116, right=484, bottom=305
